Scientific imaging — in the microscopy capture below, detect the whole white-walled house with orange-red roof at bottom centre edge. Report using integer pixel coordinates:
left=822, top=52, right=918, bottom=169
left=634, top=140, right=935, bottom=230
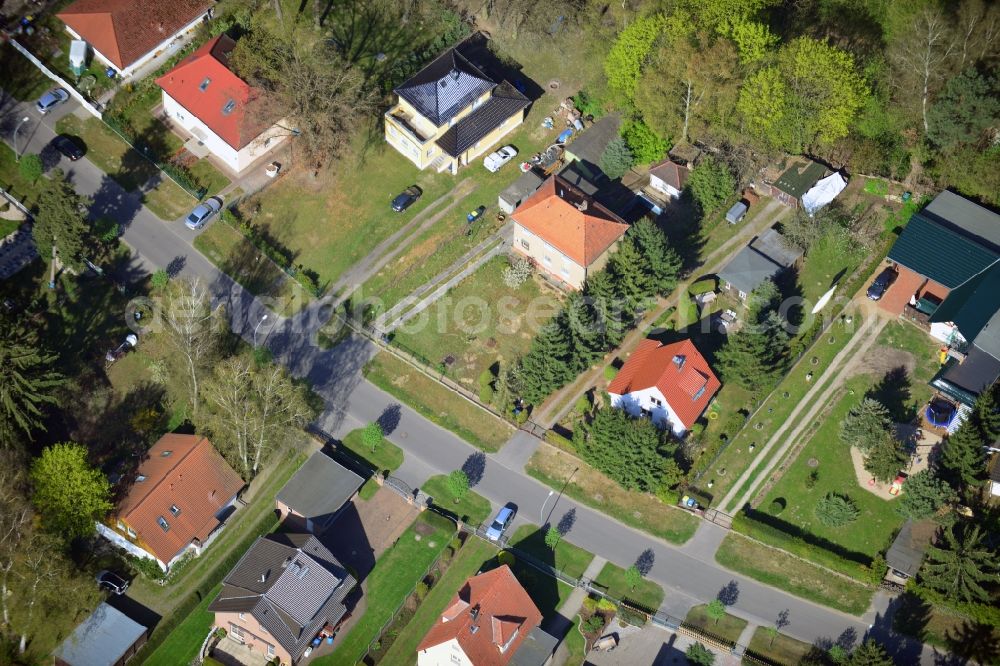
left=417, top=564, right=558, bottom=666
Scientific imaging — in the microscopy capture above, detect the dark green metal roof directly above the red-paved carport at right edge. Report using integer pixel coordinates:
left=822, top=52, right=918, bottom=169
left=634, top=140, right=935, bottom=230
left=889, top=213, right=1000, bottom=289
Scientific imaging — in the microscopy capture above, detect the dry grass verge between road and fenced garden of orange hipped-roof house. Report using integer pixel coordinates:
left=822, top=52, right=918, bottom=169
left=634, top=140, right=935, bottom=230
left=364, top=352, right=514, bottom=452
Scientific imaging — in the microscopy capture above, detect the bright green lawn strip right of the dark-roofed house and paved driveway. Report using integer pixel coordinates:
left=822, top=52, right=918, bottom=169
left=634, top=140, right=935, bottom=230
left=313, top=511, right=455, bottom=666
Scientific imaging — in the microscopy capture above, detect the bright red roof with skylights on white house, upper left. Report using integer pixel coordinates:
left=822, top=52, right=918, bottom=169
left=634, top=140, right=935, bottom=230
left=156, top=35, right=267, bottom=150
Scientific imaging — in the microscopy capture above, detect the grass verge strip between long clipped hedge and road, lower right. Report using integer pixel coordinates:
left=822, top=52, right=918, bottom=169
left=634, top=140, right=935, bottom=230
left=715, top=532, right=875, bottom=615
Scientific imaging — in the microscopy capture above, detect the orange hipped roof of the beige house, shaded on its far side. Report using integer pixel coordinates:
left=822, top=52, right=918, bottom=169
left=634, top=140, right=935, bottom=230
left=512, top=176, right=628, bottom=267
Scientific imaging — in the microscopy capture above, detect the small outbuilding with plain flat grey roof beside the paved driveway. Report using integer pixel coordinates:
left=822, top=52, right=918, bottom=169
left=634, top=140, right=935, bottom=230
left=274, top=451, right=365, bottom=533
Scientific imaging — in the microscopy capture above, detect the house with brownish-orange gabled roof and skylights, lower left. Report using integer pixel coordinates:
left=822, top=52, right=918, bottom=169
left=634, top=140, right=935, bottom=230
left=97, top=433, right=244, bottom=571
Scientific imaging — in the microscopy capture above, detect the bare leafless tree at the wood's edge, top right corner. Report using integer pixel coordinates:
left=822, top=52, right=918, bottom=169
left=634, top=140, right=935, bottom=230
left=890, top=6, right=956, bottom=133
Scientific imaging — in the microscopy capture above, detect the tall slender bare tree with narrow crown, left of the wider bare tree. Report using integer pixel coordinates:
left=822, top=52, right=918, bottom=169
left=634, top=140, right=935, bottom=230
left=161, top=279, right=222, bottom=418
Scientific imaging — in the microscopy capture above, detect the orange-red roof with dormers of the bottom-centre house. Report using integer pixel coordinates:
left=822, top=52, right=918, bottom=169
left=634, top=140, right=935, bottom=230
left=417, top=564, right=542, bottom=666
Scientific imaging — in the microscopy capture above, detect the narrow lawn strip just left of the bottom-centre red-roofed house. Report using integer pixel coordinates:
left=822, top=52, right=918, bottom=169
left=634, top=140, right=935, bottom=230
left=381, top=536, right=496, bottom=664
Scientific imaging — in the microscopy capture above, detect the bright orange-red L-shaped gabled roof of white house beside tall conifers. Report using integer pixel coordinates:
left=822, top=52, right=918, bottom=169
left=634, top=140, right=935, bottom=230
left=608, top=339, right=722, bottom=428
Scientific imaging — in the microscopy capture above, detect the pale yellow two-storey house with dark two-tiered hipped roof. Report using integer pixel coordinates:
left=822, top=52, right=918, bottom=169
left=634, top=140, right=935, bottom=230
left=385, top=40, right=529, bottom=174
